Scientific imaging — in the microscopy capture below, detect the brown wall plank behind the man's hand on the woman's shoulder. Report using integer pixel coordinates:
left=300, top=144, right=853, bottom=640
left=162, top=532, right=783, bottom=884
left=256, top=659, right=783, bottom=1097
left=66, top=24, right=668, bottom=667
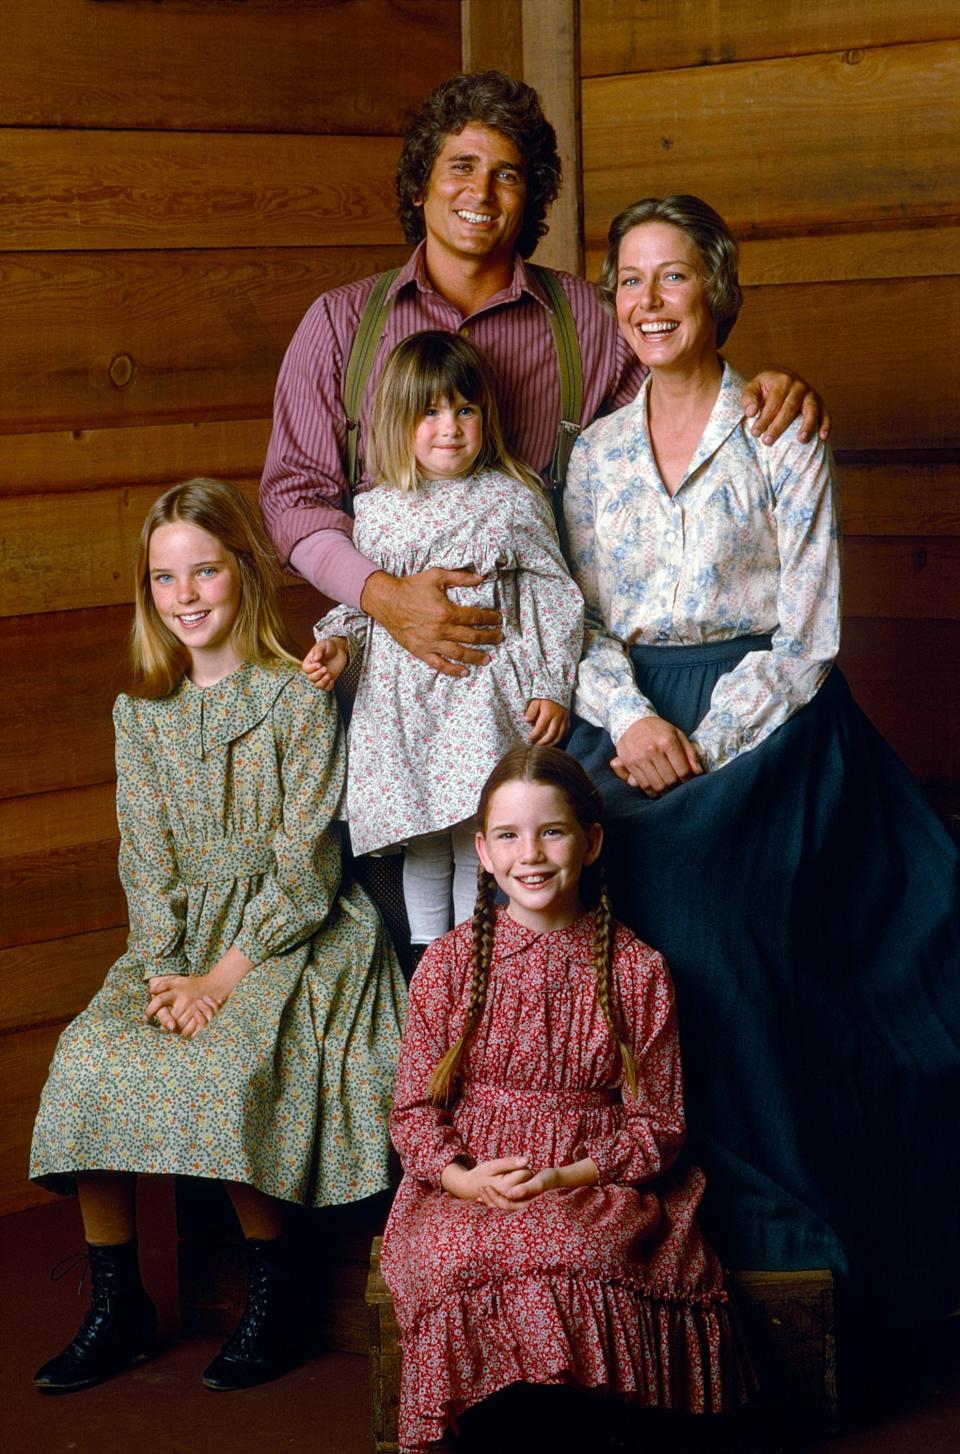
left=723, top=278, right=960, bottom=451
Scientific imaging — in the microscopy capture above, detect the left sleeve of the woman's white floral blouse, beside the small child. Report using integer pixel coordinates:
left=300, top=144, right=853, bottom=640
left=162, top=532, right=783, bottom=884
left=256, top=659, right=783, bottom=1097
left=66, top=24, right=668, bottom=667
left=563, top=438, right=657, bottom=743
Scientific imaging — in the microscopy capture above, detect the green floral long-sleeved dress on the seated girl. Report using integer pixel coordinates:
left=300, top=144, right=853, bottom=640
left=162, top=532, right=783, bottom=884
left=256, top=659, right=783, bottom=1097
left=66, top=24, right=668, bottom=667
left=31, top=662, right=406, bottom=1207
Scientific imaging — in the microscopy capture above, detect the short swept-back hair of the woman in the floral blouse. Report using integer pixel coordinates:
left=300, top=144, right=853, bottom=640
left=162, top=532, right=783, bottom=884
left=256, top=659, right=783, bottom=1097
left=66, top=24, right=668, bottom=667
left=599, top=193, right=743, bottom=348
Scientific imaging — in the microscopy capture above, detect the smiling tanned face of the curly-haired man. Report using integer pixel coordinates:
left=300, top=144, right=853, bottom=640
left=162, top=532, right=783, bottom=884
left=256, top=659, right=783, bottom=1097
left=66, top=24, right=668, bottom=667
left=417, top=122, right=527, bottom=273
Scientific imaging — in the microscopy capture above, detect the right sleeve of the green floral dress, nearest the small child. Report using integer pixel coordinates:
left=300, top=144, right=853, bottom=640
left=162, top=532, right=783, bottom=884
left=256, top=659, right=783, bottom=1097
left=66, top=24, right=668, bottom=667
left=234, top=676, right=345, bottom=964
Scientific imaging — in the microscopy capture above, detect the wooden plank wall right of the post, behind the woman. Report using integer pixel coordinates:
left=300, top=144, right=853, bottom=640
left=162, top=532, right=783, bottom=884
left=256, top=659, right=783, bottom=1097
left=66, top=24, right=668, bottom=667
left=580, top=0, right=960, bottom=806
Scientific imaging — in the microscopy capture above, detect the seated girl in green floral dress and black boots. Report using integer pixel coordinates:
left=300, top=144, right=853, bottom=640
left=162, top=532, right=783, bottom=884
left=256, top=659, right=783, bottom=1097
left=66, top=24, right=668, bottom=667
left=31, top=480, right=406, bottom=1393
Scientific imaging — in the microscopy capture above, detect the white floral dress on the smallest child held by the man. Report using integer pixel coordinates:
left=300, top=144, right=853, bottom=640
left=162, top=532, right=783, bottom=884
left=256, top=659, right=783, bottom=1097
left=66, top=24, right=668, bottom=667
left=316, top=470, right=583, bottom=853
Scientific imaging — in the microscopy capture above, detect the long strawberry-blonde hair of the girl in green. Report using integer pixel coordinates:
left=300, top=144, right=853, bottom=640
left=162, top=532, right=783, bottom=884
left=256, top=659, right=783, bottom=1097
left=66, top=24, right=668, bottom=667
left=129, top=478, right=295, bottom=696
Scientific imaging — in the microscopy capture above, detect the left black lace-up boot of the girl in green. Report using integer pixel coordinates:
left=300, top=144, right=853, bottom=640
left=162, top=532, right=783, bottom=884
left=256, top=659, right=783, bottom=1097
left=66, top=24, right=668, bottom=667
left=33, top=1242, right=157, bottom=1393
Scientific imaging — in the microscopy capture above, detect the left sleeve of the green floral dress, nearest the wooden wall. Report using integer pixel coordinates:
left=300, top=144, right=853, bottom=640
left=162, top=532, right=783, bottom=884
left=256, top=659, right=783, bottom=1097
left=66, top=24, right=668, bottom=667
left=113, top=696, right=191, bottom=979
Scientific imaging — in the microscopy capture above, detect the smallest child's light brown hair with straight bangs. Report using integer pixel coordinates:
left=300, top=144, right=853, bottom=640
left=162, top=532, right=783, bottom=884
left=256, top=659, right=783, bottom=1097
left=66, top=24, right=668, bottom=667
left=367, top=329, right=540, bottom=490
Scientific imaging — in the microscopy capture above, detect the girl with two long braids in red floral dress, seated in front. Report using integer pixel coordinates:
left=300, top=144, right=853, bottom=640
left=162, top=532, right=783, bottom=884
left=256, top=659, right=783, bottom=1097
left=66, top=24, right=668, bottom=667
left=383, top=747, right=751, bottom=1451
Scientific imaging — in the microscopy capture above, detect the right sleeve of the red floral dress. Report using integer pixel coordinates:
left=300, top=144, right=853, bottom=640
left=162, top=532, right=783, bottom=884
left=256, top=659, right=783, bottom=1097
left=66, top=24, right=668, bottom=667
left=586, top=929, right=685, bottom=1185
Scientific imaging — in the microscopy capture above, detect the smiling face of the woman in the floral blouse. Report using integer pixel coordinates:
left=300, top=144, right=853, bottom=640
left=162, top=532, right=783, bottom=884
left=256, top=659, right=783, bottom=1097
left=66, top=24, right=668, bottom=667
left=617, top=222, right=717, bottom=369
